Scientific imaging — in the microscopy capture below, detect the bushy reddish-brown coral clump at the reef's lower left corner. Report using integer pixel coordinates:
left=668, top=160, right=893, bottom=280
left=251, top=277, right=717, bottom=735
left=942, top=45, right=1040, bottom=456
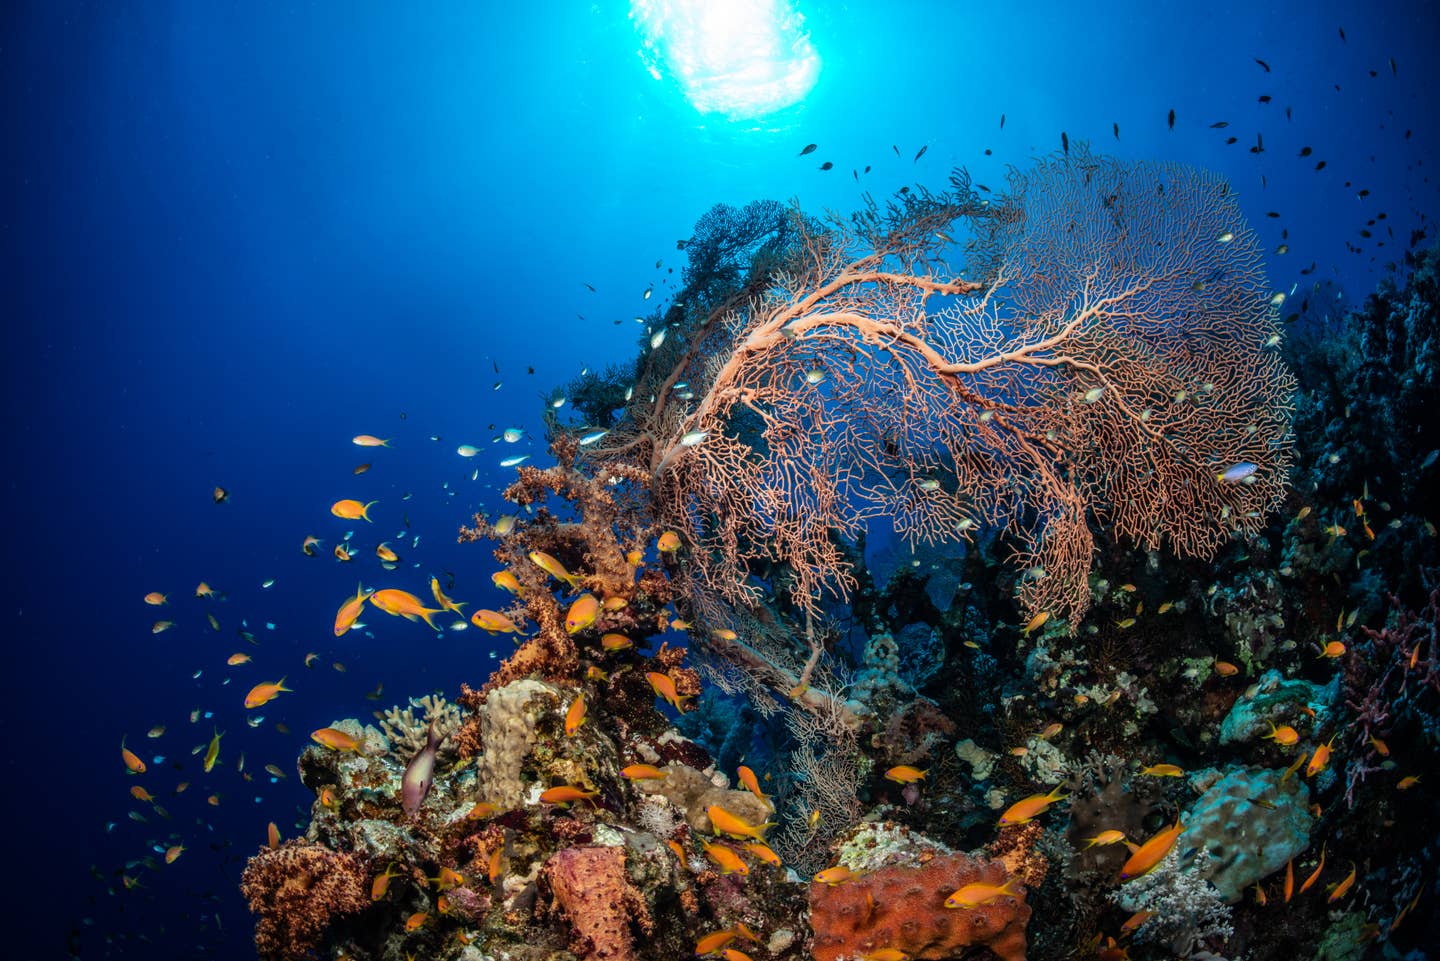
left=240, top=840, right=370, bottom=961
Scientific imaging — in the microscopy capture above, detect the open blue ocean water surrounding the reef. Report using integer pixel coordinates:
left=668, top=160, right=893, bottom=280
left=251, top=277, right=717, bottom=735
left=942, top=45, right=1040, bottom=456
left=0, top=0, right=1440, bottom=958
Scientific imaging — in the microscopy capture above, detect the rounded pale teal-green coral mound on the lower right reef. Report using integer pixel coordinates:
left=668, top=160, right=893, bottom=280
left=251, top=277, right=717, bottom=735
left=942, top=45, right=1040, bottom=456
left=1179, top=768, right=1312, bottom=903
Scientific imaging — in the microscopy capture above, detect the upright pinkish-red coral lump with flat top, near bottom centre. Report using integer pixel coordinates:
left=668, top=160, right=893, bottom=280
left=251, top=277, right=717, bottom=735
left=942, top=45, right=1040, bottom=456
left=544, top=847, right=652, bottom=961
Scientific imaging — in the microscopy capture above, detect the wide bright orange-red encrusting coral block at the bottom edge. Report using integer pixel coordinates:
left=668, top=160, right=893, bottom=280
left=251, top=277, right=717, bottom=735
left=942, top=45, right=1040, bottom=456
left=809, top=854, right=1030, bottom=961
